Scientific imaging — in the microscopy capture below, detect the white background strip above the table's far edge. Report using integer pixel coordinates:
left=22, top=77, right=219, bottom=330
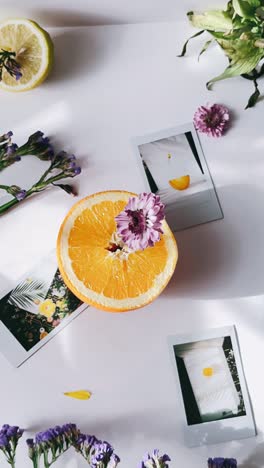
left=0, top=0, right=227, bottom=26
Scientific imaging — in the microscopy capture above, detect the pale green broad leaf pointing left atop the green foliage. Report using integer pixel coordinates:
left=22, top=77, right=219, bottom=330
left=187, top=10, right=232, bottom=32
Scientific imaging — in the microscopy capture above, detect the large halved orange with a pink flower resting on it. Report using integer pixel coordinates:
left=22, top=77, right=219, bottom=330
left=57, top=191, right=178, bottom=312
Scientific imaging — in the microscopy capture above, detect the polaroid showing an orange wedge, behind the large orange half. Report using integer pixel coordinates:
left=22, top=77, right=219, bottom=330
left=132, top=123, right=223, bottom=231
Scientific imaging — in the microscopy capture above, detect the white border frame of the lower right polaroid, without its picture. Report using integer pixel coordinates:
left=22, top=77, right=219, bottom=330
left=167, top=325, right=257, bottom=447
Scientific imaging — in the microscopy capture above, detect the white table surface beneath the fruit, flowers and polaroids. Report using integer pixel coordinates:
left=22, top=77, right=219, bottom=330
left=0, top=22, right=264, bottom=468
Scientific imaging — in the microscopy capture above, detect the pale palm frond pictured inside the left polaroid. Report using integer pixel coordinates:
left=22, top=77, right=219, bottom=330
left=8, top=280, right=45, bottom=309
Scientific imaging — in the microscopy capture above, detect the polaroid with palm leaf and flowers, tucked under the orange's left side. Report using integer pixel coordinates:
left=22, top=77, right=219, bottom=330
left=0, top=251, right=88, bottom=367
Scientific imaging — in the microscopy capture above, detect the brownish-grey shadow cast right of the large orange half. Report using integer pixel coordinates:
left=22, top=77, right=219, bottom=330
left=165, top=185, right=264, bottom=299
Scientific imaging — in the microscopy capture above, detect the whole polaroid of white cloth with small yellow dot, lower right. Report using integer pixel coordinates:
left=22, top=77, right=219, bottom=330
left=168, top=326, right=256, bottom=447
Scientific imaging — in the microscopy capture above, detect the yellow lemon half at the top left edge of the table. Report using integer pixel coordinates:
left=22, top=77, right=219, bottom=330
left=0, top=19, right=54, bottom=91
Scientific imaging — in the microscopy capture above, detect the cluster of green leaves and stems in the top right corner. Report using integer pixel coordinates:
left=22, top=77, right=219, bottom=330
left=181, top=0, right=264, bottom=108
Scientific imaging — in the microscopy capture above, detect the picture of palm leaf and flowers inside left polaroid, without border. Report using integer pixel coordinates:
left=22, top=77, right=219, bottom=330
left=0, top=254, right=82, bottom=351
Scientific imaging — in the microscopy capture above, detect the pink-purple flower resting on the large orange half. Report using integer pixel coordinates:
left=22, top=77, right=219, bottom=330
left=115, top=193, right=165, bottom=251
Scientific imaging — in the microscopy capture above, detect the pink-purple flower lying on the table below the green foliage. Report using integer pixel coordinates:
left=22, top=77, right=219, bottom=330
left=193, top=104, right=230, bottom=137
